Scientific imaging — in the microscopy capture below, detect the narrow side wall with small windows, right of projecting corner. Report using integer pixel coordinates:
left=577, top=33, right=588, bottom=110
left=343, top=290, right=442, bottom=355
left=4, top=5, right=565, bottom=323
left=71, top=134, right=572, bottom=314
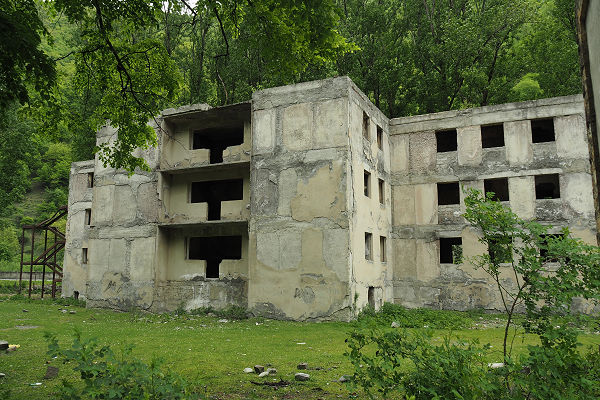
left=348, top=85, right=394, bottom=311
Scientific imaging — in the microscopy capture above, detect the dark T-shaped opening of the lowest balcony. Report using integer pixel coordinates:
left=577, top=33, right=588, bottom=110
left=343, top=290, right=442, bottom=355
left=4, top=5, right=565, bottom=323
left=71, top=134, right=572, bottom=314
left=187, top=236, right=242, bottom=278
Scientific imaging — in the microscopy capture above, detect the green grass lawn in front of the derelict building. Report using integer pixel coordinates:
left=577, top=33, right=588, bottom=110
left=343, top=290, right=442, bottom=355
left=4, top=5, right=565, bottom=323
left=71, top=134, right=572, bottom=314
left=0, top=297, right=600, bottom=399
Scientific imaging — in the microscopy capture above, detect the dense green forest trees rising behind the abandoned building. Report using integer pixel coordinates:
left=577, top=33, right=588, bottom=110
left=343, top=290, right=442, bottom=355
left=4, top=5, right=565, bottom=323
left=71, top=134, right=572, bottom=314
left=0, top=0, right=581, bottom=268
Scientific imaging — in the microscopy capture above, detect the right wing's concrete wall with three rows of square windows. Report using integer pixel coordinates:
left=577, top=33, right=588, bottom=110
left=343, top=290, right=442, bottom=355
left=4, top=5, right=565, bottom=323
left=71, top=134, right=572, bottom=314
left=390, top=96, right=595, bottom=310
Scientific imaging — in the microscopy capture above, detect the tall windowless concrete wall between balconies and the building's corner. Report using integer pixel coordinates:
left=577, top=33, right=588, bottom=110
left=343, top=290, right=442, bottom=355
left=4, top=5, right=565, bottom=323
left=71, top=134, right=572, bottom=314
left=248, top=78, right=353, bottom=320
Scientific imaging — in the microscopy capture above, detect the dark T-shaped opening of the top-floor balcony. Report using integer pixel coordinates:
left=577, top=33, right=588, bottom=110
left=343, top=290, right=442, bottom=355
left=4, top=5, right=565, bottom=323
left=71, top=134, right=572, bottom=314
left=192, top=125, right=244, bottom=164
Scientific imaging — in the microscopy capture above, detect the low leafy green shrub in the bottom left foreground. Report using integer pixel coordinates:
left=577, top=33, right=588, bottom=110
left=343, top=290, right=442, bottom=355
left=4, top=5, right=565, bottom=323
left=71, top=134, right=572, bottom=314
left=44, top=331, right=199, bottom=400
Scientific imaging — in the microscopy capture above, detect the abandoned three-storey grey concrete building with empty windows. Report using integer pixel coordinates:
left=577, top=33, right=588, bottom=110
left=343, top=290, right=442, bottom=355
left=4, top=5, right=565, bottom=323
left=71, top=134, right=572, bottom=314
left=63, top=77, right=596, bottom=320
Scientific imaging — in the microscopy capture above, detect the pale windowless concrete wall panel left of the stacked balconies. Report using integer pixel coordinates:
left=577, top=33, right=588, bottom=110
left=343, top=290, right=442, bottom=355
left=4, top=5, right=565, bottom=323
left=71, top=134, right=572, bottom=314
left=81, top=126, right=159, bottom=310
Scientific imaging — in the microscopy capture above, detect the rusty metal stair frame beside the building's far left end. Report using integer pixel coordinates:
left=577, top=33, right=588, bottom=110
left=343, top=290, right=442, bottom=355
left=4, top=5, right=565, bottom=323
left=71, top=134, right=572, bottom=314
left=19, top=206, right=67, bottom=298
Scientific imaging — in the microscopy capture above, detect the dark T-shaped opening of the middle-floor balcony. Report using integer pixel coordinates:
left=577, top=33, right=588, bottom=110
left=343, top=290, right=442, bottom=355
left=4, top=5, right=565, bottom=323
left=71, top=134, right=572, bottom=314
left=190, top=179, right=244, bottom=221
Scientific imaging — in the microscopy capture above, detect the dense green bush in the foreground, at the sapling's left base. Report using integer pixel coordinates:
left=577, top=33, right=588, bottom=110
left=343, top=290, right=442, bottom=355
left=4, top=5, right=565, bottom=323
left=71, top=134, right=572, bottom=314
left=347, top=329, right=502, bottom=400
